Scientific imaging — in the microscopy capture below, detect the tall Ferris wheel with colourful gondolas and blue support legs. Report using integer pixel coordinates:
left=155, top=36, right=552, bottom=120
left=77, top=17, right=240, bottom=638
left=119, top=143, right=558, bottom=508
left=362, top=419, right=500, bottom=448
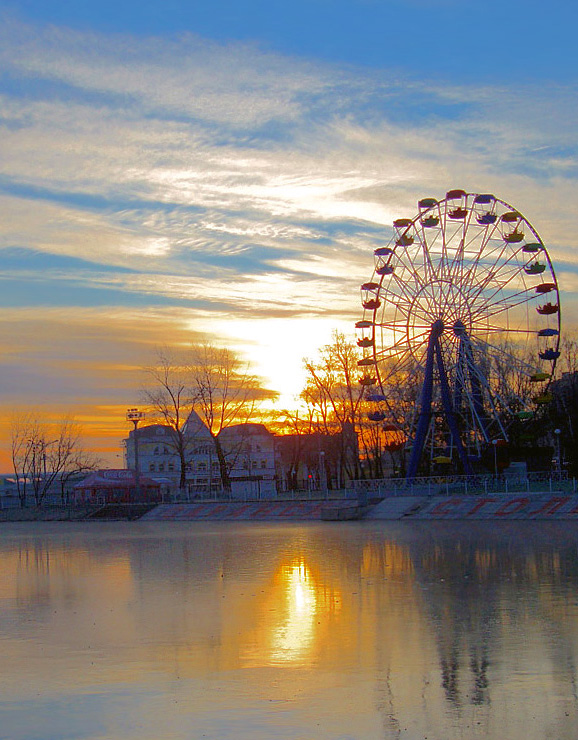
left=356, top=190, right=560, bottom=478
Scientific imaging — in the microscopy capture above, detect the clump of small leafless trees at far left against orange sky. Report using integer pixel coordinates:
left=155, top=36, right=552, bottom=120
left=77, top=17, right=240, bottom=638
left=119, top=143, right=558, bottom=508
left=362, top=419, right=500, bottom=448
left=11, top=412, right=98, bottom=507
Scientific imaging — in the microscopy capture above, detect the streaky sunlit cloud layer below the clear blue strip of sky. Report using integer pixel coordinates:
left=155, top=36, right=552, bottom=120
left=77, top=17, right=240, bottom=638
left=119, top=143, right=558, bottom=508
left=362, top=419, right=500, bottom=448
left=0, top=18, right=578, bottom=462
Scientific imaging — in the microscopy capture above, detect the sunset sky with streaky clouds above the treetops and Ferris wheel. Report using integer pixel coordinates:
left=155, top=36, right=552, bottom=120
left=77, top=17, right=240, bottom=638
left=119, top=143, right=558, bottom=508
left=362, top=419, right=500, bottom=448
left=0, top=0, right=578, bottom=469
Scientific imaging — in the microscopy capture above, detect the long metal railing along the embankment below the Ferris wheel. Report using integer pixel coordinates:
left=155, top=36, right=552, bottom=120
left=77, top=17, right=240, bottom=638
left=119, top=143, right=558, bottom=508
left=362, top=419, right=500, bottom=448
left=353, top=471, right=577, bottom=500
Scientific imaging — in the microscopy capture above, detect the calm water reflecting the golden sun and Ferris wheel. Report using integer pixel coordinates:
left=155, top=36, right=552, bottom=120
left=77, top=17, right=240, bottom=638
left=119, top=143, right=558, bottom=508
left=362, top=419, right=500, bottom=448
left=0, top=522, right=578, bottom=740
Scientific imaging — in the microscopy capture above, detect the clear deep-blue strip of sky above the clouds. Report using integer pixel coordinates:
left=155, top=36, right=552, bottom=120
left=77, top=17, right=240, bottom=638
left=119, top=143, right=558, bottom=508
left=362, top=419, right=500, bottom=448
left=6, top=0, right=577, bottom=82
